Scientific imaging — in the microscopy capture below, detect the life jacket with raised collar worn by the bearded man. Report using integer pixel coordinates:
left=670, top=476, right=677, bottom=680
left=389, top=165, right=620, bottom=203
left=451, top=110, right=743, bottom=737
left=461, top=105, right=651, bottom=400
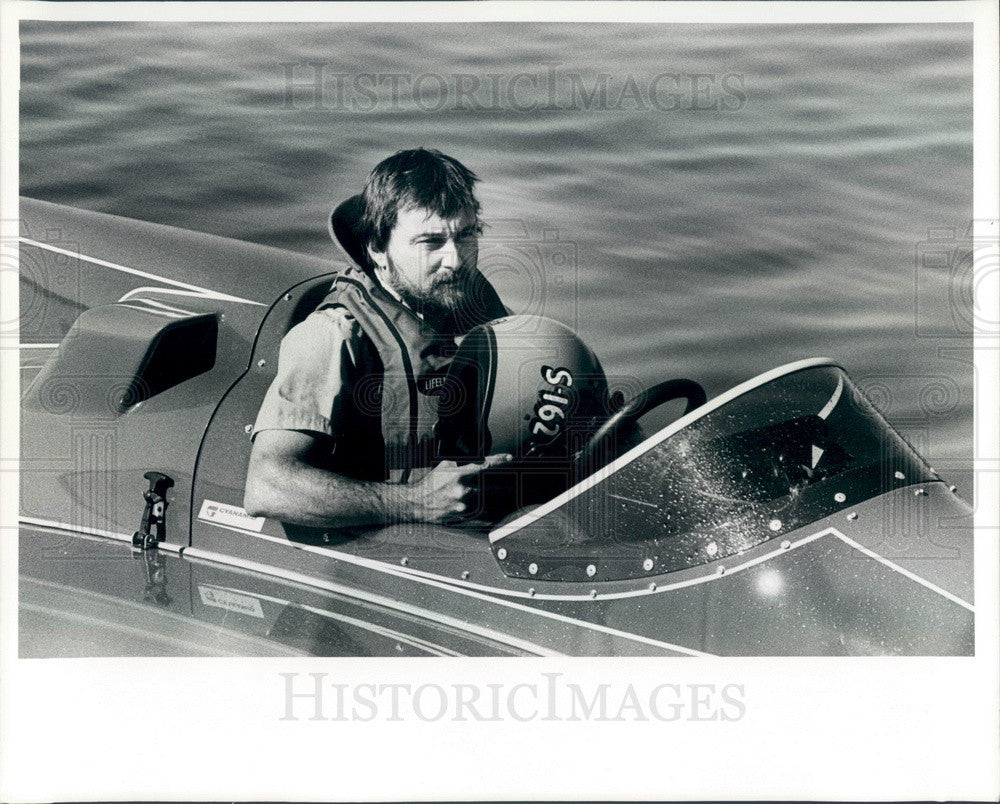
left=317, top=197, right=507, bottom=483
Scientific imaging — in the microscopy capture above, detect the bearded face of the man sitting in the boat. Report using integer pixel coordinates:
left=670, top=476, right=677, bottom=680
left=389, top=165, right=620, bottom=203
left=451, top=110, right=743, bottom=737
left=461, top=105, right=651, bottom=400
left=368, top=207, right=479, bottom=318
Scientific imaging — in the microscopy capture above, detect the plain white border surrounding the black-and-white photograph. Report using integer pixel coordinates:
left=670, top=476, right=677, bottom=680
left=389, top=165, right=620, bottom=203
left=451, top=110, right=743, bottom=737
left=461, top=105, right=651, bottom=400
left=0, top=0, right=1000, bottom=801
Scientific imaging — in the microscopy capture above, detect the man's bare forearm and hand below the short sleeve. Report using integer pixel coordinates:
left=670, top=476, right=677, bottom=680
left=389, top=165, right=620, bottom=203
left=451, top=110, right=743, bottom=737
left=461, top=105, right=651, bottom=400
left=243, top=430, right=510, bottom=527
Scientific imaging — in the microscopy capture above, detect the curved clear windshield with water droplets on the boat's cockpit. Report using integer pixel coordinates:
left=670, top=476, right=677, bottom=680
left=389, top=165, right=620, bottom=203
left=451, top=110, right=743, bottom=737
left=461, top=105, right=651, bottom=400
left=493, top=365, right=934, bottom=581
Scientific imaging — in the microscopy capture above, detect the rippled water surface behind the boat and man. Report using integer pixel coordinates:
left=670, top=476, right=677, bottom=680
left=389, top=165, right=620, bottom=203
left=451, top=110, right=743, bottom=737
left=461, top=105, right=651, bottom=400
left=21, top=22, right=973, bottom=490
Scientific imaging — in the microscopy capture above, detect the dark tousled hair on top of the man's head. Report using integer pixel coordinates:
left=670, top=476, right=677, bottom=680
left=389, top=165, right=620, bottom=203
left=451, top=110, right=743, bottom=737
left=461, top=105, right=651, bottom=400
left=362, top=148, right=480, bottom=251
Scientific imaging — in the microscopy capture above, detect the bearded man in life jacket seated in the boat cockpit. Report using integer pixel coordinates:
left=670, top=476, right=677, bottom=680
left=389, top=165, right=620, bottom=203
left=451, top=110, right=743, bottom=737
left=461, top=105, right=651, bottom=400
left=244, top=148, right=510, bottom=527
